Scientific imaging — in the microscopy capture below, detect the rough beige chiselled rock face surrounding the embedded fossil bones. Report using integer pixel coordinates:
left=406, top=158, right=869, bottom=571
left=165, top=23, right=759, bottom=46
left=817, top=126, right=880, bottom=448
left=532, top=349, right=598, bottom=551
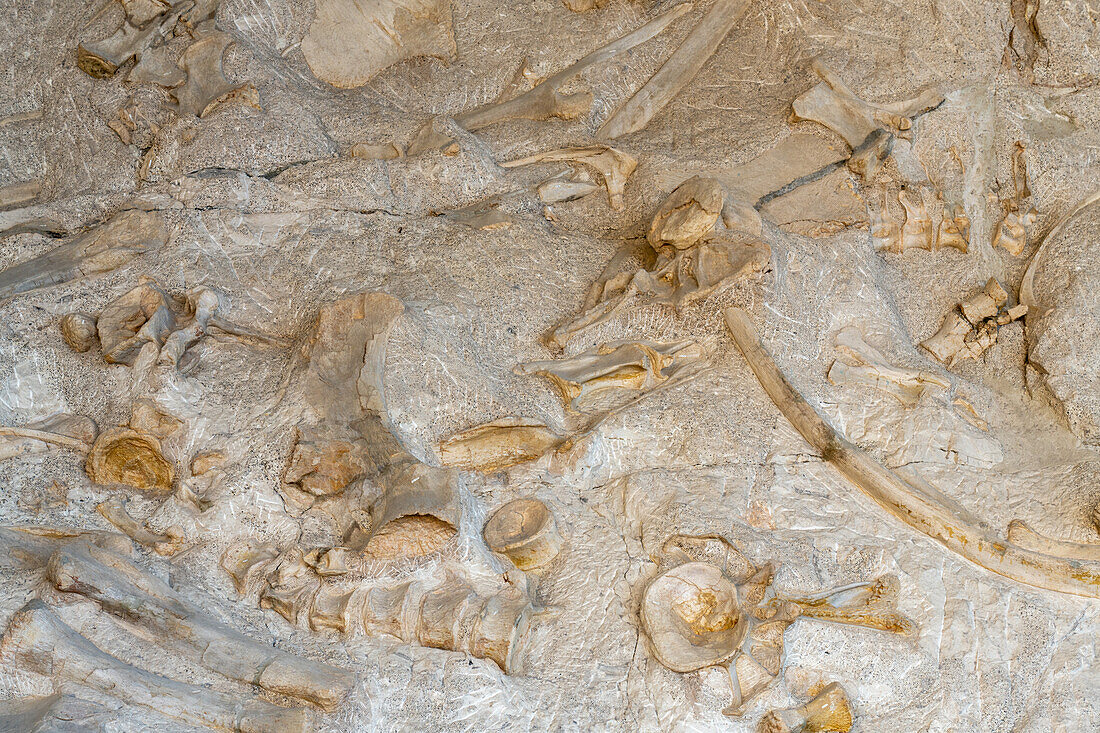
left=0, top=0, right=1100, bottom=733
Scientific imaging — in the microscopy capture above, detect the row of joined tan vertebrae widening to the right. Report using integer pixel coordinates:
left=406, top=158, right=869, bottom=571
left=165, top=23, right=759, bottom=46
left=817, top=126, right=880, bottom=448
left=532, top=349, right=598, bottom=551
left=222, top=544, right=538, bottom=674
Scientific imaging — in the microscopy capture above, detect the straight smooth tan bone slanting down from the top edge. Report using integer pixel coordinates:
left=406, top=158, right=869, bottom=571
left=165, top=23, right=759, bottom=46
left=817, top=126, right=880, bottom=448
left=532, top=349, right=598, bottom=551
left=596, top=0, right=750, bottom=140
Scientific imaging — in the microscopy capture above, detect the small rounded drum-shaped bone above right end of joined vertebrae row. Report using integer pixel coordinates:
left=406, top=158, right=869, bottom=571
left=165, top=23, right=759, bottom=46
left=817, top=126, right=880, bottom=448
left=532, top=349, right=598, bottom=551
left=482, top=497, right=563, bottom=570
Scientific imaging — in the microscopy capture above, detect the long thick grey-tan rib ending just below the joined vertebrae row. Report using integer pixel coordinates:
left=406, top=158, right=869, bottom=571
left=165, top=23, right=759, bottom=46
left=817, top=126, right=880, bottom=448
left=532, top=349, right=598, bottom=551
left=46, top=545, right=355, bottom=710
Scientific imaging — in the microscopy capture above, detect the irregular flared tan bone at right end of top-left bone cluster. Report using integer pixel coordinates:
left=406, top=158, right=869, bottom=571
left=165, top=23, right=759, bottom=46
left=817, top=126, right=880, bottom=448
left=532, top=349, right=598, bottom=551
left=172, top=31, right=260, bottom=117
